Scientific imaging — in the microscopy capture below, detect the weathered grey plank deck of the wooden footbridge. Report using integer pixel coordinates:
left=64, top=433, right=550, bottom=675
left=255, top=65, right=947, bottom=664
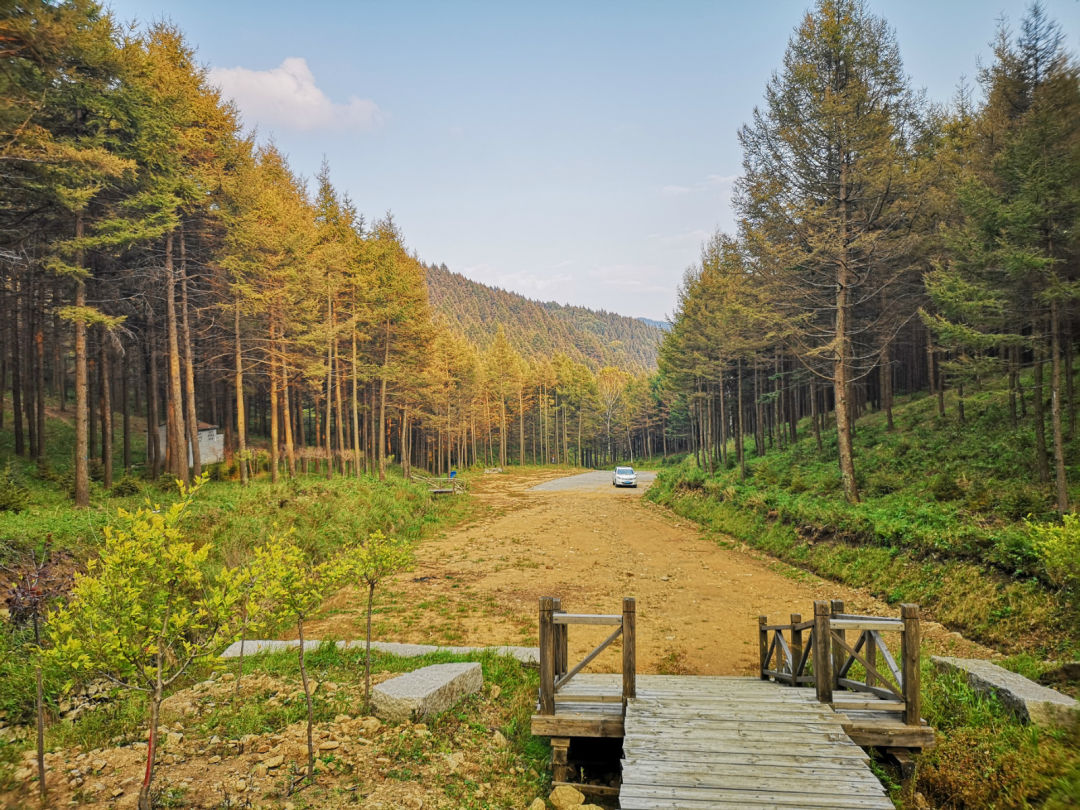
left=532, top=674, right=893, bottom=810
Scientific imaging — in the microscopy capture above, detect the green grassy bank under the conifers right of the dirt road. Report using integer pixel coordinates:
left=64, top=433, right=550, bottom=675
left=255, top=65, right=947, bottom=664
left=647, top=380, right=1080, bottom=658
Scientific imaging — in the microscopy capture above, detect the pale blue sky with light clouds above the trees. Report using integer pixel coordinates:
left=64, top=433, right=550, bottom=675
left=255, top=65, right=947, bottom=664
left=106, top=0, right=1080, bottom=320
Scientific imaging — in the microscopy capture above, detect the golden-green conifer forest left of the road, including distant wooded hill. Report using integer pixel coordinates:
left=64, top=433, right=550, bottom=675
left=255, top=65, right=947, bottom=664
left=0, top=2, right=663, bottom=505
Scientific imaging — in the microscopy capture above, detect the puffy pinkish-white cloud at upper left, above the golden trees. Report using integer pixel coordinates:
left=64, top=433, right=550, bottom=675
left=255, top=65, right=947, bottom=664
left=210, top=56, right=386, bottom=132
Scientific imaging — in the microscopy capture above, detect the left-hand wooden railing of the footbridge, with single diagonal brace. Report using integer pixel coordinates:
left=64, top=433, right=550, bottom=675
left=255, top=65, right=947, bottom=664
left=539, top=596, right=637, bottom=715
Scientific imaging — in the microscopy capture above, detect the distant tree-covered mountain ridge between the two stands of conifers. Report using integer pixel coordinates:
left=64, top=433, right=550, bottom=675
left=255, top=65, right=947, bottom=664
left=427, top=265, right=663, bottom=372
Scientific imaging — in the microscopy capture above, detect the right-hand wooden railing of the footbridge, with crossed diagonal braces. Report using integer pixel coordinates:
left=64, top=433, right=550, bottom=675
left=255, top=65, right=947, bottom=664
left=758, top=599, right=921, bottom=726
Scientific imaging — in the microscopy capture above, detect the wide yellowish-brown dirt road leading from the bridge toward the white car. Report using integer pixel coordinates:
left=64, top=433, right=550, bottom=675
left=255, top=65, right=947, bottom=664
left=311, top=471, right=988, bottom=675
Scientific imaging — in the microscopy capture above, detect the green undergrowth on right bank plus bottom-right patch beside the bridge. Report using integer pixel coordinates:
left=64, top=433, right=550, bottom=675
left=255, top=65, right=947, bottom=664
left=646, top=384, right=1080, bottom=808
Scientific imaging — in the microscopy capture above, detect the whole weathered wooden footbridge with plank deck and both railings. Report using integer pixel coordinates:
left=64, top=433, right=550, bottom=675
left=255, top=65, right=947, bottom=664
left=532, top=597, right=934, bottom=810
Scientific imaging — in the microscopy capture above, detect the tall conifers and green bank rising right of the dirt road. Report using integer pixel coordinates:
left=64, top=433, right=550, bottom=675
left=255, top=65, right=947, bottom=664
left=660, top=0, right=1080, bottom=648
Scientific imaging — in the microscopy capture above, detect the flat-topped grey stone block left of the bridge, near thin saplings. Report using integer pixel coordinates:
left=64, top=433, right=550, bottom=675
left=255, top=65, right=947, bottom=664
left=372, top=663, right=484, bottom=723
